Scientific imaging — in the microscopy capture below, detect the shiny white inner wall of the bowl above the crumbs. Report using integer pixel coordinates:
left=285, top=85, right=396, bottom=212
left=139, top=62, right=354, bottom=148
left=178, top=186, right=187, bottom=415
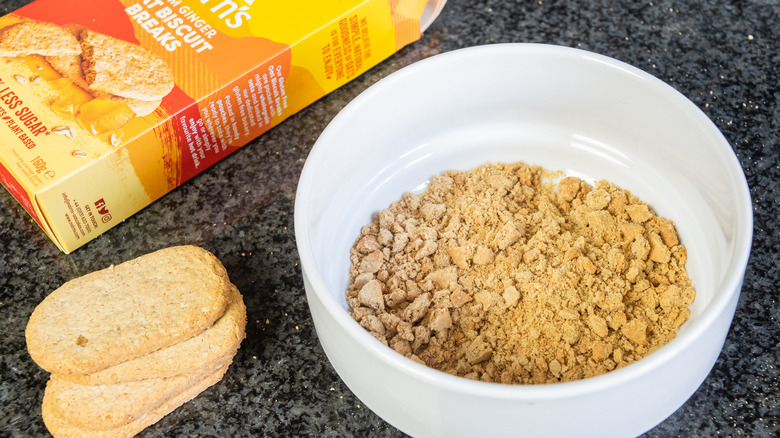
left=295, top=44, right=752, bottom=356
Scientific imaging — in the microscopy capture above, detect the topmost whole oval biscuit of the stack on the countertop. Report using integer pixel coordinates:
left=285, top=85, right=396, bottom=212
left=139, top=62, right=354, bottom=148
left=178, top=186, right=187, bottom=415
left=25, top=246, right=230, bottom=375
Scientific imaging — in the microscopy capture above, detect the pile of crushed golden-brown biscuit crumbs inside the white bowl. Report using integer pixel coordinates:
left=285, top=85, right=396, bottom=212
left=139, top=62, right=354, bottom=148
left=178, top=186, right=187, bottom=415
left=347, top=163, right=695, bottom=384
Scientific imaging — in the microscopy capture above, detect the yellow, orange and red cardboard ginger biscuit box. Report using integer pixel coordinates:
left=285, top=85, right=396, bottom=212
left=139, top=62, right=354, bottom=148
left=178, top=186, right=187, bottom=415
left=0, top=0, right=444, bottom=252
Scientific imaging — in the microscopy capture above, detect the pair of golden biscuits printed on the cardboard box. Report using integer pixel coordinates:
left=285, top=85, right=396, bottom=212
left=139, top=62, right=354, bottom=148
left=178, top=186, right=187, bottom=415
left=0, top=21, right=174, bottom=117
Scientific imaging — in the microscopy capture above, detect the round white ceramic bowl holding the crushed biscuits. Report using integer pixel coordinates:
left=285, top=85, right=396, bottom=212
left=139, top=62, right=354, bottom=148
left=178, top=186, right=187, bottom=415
left=295, top=44, right=752, bottom=437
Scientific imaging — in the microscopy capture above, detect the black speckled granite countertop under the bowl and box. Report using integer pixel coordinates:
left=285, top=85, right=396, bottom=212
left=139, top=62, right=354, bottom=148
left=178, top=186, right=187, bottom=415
left=0, top=0, right=780, bottom=437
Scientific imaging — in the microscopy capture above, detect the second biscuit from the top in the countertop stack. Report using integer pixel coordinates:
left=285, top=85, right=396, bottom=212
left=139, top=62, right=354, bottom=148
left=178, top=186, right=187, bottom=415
left=58, top=285, right=246, bottom=385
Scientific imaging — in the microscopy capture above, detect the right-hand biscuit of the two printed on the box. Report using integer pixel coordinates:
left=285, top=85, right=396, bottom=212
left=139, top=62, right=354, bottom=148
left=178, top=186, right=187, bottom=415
left=80, top=29, right=174, bottom=101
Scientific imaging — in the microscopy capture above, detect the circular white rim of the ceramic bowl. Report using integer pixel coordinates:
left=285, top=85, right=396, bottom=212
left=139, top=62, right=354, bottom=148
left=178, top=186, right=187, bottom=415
left=294, top=43, right=753, bottom=401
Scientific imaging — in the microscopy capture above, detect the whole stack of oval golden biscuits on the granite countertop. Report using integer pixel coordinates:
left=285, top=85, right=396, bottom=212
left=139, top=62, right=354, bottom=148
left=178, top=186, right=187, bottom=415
left=26, top=246, right=246, bottom=437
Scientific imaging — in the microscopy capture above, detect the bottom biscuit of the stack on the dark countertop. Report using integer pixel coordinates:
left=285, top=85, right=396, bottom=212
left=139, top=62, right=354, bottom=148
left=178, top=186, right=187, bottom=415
left=42, top=365, right=228, bottom=438
